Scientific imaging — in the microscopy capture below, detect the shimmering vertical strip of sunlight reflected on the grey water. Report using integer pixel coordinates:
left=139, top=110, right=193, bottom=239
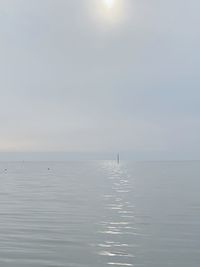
left=95, top=162, right=142, bottom=267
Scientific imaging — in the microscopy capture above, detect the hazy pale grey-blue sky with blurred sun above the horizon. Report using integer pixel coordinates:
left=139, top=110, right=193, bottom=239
left=0, top=0, right=200, bottom=160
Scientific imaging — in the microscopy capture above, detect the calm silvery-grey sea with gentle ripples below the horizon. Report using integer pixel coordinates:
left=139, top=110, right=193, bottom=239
left=0, top=161, right=200, bottom=267
